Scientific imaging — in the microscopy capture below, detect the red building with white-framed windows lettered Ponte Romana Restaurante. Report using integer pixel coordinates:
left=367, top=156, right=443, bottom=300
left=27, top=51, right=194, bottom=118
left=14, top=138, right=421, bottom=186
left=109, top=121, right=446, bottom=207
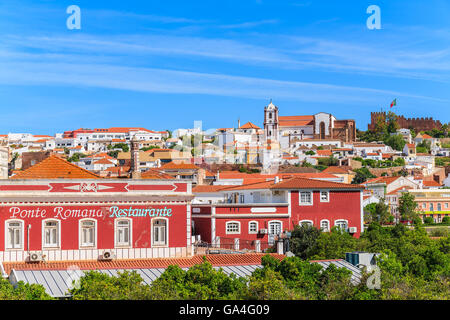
left=0, top=156, right=193, bottom=262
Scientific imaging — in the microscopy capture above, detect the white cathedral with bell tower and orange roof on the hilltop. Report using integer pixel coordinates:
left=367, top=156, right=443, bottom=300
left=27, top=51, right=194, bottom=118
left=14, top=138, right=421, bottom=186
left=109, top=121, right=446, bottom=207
left=264, top=102, right=356, bottom=143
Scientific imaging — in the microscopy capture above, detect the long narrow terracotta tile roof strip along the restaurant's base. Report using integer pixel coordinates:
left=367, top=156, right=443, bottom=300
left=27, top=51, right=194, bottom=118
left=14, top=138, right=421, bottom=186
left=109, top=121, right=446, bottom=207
left=3, top=253, right=285, bottom=274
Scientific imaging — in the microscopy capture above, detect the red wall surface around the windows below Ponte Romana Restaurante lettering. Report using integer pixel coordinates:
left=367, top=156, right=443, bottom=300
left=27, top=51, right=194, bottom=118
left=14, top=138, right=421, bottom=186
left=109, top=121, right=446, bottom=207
left=0, top=204, right=187, bottom=250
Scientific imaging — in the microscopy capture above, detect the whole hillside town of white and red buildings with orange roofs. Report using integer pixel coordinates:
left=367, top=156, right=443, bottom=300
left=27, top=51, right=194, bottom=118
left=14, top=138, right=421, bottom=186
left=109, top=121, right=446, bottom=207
left=0, top=101, right=450, bottom=297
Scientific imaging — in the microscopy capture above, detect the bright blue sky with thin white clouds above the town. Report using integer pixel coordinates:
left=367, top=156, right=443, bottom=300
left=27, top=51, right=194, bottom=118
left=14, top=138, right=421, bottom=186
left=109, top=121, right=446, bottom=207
left=0, top=0, right=450, bottom=134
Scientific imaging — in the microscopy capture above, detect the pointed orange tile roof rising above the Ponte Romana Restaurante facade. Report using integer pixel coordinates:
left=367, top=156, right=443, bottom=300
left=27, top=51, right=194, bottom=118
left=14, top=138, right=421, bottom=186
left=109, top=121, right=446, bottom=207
left=10, top=155, right=100, bottom=179
